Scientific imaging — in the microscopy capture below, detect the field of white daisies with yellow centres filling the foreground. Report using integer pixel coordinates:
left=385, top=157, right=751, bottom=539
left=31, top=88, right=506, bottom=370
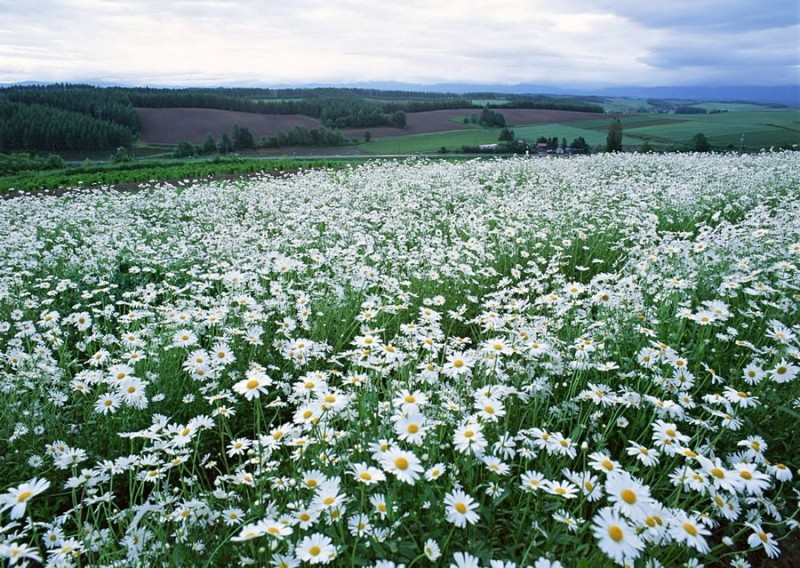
left=0, top=152, right=800, bottom=568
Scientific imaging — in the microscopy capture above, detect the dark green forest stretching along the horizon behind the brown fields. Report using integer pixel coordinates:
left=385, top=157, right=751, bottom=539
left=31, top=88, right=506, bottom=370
left=0, top=84, right=602, bottom=152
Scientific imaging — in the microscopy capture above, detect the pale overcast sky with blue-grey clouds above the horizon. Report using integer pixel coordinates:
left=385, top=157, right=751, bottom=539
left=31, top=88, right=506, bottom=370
left=0, top=0, right=800, bottom=87
